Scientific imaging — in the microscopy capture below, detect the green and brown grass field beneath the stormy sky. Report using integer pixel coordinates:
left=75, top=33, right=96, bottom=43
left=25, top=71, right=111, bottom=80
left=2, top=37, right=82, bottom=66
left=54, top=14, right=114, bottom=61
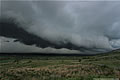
left=0, top=51, right=120, bottom=80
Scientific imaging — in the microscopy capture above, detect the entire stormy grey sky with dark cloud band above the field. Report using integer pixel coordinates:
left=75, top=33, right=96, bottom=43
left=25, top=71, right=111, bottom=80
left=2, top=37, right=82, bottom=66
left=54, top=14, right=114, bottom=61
left=0, top=1, right=120, bottom=54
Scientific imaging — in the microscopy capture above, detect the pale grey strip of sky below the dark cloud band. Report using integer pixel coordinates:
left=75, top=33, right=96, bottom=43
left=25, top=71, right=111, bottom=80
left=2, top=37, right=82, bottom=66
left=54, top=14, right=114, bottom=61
left=0, top=37, right=81, bottom=54
